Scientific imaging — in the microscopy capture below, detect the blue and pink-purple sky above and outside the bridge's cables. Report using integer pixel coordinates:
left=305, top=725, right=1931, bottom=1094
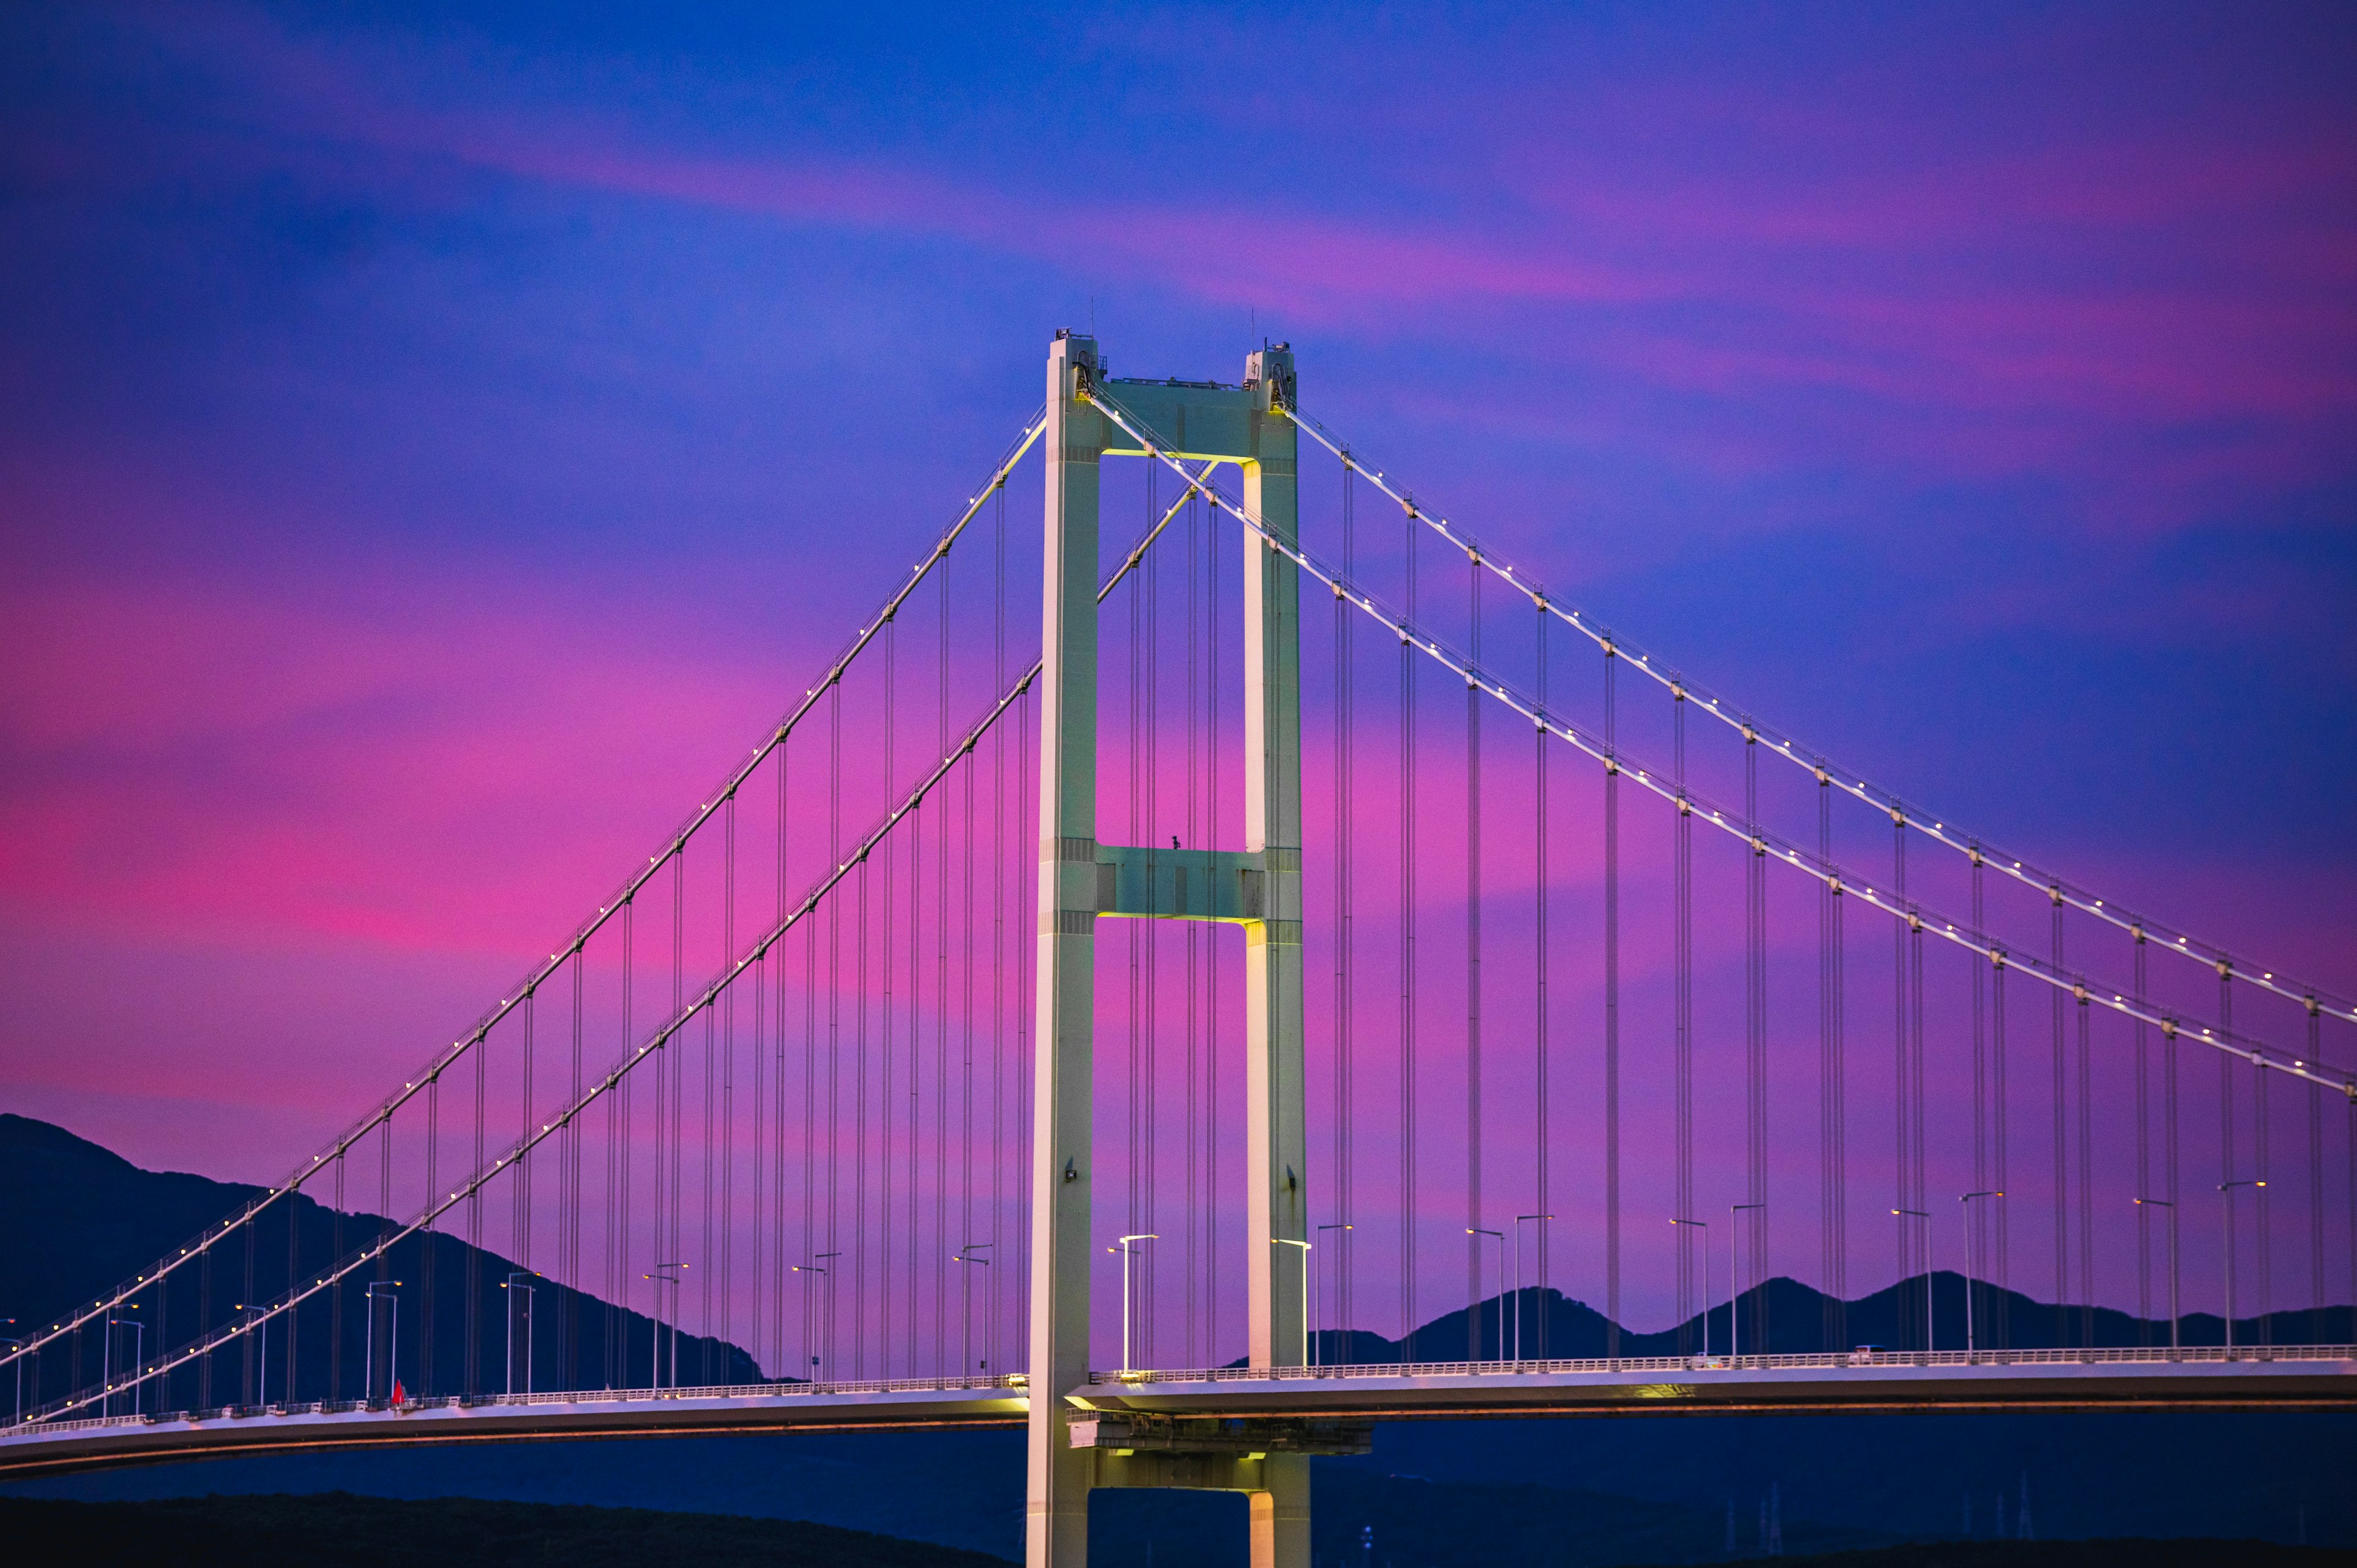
left=0, top=5, right=2357, bottom=1339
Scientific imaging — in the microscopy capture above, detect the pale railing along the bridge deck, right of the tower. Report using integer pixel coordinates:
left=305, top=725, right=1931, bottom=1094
left=1089, top=1344, right=2357, bottom=1384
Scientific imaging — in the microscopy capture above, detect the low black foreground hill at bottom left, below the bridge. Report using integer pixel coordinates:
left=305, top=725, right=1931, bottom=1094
left=0, top=1493, right=1007, bottom=1568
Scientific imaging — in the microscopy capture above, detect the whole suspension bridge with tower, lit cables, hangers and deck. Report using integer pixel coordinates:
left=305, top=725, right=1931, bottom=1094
left=0, top=335, right=2357, bottom=1566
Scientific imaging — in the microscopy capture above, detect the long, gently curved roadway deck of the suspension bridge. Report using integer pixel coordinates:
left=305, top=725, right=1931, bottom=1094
left=0, top=1344, right=2357, bottom=1478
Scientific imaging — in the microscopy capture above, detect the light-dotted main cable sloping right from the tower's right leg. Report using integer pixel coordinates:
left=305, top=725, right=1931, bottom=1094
left=1280, top=406, right=2357, bottom=1023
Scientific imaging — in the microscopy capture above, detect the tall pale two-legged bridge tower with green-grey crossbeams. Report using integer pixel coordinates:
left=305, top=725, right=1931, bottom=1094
left=1025, top=333, right=1310, bottom=1568
